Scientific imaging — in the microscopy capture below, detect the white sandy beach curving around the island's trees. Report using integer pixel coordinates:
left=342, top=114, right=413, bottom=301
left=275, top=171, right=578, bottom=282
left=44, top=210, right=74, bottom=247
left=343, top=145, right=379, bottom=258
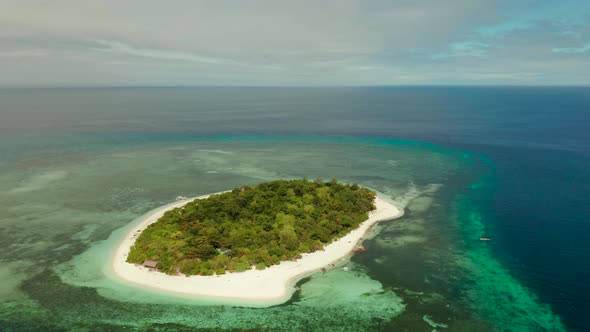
left=112, top=191, right=403, bottom=305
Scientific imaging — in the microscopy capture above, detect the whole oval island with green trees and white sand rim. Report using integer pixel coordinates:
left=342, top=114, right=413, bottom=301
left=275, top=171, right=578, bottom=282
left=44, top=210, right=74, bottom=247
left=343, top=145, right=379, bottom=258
left=112, top=179, right=403, bottom=305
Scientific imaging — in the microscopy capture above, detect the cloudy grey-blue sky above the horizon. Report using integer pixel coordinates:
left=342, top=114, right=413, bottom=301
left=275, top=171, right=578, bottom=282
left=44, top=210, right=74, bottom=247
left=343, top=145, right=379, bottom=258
left=0, top=0, right=590, bottom=87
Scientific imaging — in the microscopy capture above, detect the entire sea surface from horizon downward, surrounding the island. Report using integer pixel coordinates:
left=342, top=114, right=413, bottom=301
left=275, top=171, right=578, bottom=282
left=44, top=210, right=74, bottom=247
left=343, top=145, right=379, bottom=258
left=0, top=87, right=590, bottom=331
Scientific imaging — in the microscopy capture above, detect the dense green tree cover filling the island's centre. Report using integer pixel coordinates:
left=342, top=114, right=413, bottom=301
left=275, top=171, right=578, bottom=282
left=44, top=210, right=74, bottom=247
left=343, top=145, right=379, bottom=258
left=127, top=179, right=375, bottom=275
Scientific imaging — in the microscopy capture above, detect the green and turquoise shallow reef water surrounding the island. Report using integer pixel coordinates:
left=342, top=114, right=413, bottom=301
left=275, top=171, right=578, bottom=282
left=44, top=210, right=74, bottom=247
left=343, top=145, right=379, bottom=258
left=0, top=134, right=564, bottom=331
